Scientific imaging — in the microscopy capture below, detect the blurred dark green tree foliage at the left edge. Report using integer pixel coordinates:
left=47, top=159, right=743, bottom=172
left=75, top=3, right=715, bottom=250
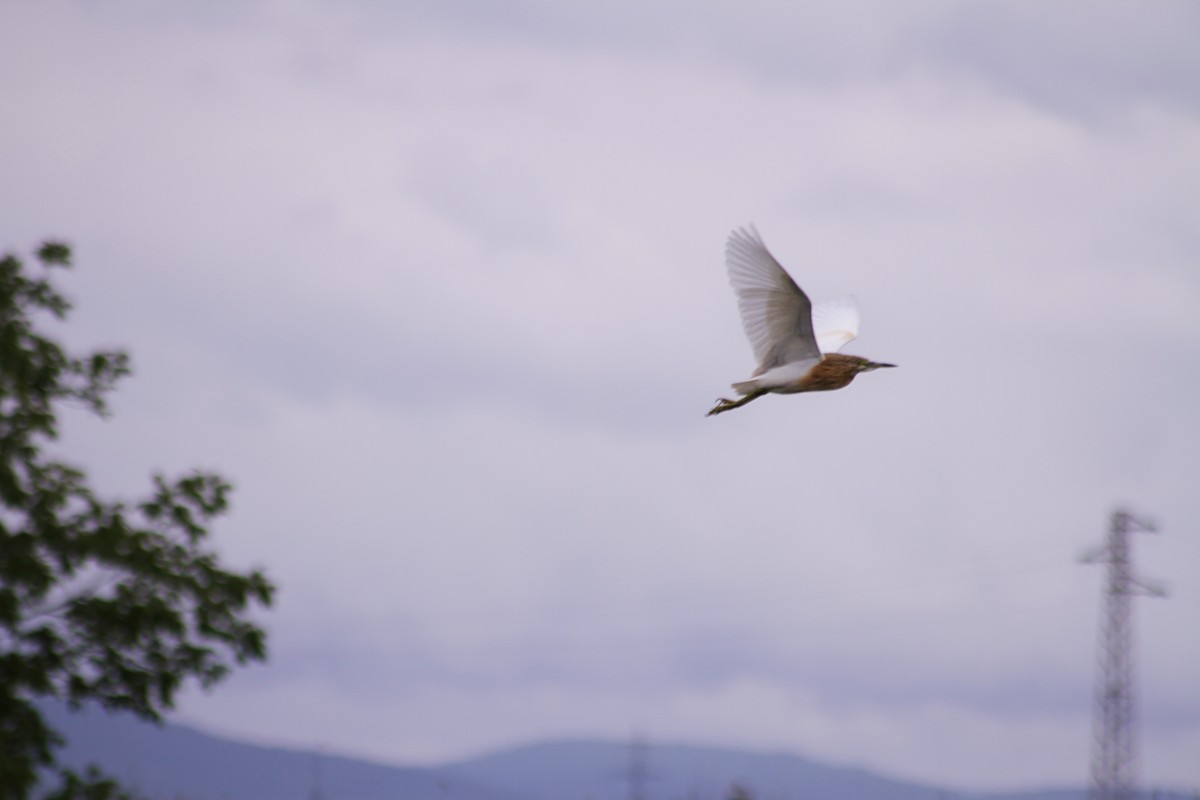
left=0, top=242, right=274, bottom=800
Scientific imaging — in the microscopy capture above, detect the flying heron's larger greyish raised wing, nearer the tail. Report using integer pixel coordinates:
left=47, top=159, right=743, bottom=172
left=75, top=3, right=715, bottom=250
left=725, top=225, right=821, bottom=375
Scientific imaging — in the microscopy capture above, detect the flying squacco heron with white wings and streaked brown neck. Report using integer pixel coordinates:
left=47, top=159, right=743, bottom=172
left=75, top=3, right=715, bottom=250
left=708, top=225, right=895, bottom=416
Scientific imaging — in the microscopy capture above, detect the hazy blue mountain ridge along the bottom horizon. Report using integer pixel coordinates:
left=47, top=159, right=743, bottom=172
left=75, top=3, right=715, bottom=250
left=43, top=705, right=1192, bottom=800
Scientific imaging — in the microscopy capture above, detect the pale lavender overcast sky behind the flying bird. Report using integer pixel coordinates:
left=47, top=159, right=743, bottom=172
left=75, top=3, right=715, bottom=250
left=0, top=0, right=1200, bottom=788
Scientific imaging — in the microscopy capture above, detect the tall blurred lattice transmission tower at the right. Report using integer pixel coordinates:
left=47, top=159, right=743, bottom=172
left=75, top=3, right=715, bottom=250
left=1082, top=511, right=1166, bottom=800
